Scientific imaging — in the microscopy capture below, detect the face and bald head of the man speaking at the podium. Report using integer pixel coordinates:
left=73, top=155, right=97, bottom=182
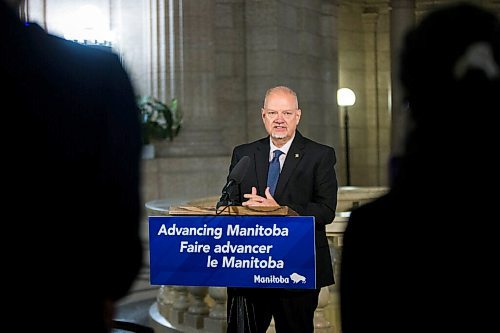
left=262, top=91, right=301, bottom=146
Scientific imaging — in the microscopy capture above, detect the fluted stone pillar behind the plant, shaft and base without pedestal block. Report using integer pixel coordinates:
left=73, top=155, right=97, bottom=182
left=150, top=0, right=230, bottom=157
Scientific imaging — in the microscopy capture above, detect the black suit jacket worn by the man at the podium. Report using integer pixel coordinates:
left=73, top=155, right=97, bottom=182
left=230, top=131, right=337, bottom=288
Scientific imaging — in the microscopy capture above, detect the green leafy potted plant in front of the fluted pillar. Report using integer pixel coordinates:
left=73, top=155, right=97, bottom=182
left=137, top=96, right=182, bottom=158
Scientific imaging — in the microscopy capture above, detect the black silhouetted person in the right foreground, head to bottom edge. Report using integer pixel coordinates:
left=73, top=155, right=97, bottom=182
left=340, top=4, right=500, bottom=333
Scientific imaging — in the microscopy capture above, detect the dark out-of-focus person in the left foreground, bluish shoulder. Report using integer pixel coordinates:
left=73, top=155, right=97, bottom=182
left=0, top=0, right=142, bottom=332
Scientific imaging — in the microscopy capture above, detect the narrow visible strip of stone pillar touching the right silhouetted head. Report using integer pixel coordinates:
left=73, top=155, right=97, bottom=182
left=390, top=0, right=415, bottom=156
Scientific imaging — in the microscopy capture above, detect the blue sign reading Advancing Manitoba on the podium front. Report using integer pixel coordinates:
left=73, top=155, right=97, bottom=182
left=149, top=216, right=316, bottom=289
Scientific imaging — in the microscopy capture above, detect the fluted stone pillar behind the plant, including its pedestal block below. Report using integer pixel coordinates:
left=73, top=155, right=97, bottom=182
left=144, top=0, right=231, bottom=208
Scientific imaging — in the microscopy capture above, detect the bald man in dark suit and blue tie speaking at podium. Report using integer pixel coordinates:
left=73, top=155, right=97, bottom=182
left=227, top=86, right=337, bottom=333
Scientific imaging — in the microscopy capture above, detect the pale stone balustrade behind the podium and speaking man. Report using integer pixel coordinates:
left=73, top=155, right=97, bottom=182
left=146, top=186, right=387, bottom=333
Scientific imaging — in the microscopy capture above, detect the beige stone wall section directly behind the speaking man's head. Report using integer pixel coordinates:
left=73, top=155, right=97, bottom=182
left=244, top=0, right=339, bottom=147
